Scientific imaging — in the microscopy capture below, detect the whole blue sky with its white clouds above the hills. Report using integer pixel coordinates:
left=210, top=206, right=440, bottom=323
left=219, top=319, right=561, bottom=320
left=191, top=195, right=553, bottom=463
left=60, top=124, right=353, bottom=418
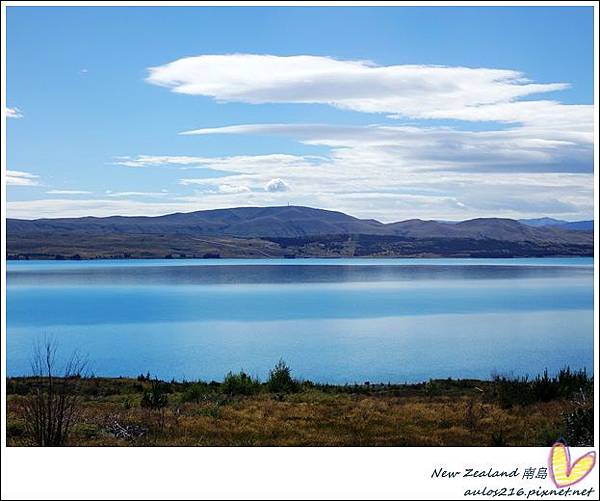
left=5, top=6, right=594, bottom=222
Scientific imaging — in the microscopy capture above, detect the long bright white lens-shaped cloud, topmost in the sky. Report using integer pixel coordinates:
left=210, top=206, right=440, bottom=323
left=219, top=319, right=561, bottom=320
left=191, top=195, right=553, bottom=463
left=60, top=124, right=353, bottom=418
left=147, top=54, right=593, bottom=124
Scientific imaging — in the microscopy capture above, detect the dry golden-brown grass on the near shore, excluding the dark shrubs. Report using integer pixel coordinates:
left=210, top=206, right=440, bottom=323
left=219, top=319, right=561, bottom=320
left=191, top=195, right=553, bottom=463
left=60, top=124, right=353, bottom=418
left=7, top=379, right=571, bottom=446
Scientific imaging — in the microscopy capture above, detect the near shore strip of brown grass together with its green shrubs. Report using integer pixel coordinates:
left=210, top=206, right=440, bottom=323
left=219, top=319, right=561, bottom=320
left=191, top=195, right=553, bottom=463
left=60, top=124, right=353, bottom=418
left=7, top=366, right=593, bottom=446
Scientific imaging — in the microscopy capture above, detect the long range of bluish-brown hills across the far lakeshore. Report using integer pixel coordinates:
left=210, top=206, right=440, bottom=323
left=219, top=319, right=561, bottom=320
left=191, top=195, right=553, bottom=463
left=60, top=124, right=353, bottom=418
left=7, top=206, right=593, bottom=258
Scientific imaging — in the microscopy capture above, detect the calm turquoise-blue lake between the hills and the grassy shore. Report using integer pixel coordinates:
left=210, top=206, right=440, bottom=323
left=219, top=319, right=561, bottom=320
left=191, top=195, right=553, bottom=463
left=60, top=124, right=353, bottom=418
left=7, top=258, right=594, bottom=383
